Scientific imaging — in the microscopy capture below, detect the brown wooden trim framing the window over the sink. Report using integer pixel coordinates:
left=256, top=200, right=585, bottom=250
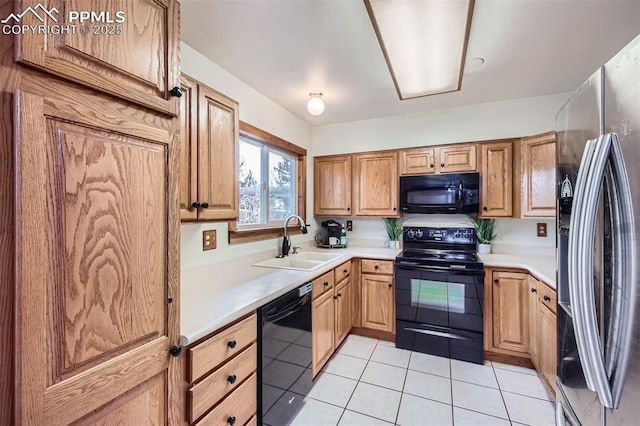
left=228, top=121, right=308, bottom=244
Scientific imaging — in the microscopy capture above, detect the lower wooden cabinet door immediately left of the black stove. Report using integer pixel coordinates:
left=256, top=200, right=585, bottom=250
left=361, top=274, right=395, bottom=332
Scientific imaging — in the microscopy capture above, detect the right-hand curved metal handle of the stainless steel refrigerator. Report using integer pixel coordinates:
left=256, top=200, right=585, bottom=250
left=607, top=134, right=638, bottom=408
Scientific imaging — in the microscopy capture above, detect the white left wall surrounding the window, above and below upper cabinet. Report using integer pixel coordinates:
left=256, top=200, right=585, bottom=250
left=180, top=43, right=313, bottom=268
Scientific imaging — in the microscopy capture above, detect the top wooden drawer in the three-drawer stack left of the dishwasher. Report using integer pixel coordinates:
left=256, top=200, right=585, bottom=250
left=189, top=314, right=257, bottom=383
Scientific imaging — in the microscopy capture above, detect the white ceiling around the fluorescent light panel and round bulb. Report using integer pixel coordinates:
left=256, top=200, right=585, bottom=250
left=181, top=0, right=640, bottom=126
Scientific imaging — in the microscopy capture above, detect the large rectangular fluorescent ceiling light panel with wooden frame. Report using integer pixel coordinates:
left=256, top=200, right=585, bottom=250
left=364, top=0, right=474, bottom=100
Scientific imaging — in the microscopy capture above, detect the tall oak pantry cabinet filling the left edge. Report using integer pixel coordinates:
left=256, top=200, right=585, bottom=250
left=0, top=0, right=184, bottom=424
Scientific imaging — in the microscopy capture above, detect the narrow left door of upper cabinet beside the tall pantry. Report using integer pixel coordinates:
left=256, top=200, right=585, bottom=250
left=179, top=75, right=198, bottom=220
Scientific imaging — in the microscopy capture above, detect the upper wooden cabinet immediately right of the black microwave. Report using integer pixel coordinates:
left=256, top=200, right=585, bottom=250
left=480, top=141, right=513, bottom=217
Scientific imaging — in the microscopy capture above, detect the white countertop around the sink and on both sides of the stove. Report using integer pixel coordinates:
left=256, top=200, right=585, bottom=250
left=180, top=247, right=556, bottom=345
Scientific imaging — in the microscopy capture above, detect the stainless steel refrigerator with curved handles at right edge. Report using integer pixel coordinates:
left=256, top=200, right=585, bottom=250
left=556, top=36, right=640, bottom=426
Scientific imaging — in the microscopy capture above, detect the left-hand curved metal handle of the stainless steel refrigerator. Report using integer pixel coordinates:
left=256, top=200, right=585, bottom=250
left=569, top=134, right=613, bottom=408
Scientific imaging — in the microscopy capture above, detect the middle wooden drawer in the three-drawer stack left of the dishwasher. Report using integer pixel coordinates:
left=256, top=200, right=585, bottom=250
left=188, top=343, right=258, bottom=422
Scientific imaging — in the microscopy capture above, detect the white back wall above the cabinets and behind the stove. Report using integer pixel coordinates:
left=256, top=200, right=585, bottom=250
left=312, top=93, right=571, bottom=247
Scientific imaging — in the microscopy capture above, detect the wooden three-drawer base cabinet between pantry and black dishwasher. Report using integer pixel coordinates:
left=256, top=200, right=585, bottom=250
left=187, top=313, right=258, bottom=426
